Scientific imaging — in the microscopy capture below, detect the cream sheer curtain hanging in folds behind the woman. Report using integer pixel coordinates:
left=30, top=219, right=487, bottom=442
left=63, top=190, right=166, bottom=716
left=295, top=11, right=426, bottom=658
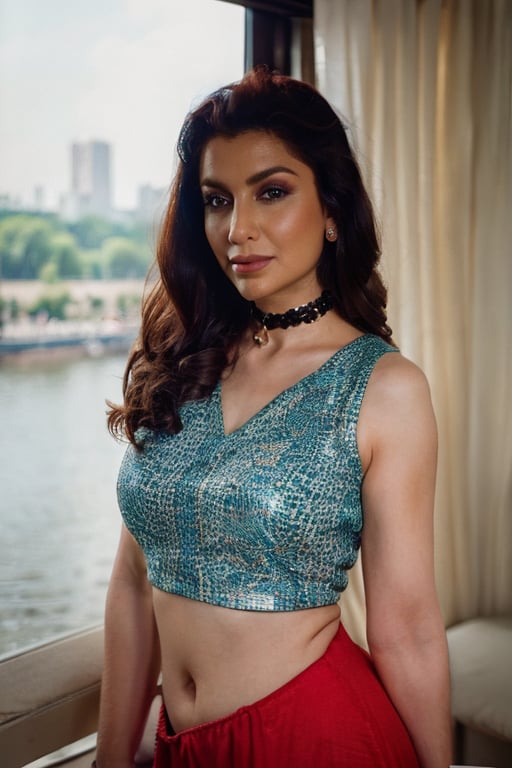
left=314, top=0, right=512, bottom=641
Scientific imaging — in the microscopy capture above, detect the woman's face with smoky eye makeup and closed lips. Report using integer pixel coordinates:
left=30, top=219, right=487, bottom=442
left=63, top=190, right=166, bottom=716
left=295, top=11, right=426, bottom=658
left=200, top=131, right=334, bottom=312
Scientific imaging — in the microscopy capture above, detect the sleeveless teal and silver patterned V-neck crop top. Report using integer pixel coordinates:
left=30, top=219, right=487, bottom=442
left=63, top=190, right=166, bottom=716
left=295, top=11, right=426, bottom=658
left=118, top=335, right=393, bottom=611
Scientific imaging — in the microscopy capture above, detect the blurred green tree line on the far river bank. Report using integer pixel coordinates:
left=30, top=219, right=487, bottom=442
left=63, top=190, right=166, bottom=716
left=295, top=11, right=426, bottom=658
left=0, top=212, right=152, bottom=283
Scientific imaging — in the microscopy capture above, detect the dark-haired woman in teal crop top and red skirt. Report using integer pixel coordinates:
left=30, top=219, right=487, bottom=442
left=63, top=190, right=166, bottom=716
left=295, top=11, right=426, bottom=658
left=97, top=70, right=450, bottom=768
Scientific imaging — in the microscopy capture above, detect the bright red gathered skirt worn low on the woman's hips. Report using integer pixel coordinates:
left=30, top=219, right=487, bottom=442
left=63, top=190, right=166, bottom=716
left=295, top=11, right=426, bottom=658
left=153, top=625, right=419, bottom=768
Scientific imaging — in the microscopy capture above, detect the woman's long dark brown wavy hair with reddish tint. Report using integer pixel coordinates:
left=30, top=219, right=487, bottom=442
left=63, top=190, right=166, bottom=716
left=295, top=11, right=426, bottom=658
left=108, top=68, right=392, bottom=446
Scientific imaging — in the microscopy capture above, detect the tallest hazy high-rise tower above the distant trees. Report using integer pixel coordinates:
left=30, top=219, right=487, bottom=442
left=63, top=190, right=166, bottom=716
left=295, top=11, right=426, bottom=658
left=70, top=141, right=112, bottom=217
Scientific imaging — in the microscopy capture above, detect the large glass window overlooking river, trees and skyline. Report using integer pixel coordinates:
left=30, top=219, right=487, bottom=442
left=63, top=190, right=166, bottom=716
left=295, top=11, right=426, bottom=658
left=0, top=0, right=244, bottom=655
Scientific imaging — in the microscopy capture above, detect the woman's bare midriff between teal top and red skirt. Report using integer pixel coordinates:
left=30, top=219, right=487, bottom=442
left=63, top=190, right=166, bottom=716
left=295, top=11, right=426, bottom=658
left=153, top=589, right=340, bottom=733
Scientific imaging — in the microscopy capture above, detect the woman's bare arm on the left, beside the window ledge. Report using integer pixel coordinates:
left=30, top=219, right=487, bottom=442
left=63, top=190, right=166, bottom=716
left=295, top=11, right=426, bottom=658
left=96, top=526, right=160, bottom=768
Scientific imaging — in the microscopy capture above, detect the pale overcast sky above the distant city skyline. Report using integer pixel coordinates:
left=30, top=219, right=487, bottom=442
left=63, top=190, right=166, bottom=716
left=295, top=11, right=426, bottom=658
left=0, top=0, right=244, bottom=208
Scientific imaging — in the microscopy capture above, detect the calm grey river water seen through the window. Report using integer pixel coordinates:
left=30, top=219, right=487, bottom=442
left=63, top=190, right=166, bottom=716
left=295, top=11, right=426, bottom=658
left=0, top=356, right=125, bottom=655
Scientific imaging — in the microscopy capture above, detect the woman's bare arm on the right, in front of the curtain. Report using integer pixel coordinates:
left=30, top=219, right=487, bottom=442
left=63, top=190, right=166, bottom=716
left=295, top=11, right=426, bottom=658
left=360, top=354, right=452, bottom=768
